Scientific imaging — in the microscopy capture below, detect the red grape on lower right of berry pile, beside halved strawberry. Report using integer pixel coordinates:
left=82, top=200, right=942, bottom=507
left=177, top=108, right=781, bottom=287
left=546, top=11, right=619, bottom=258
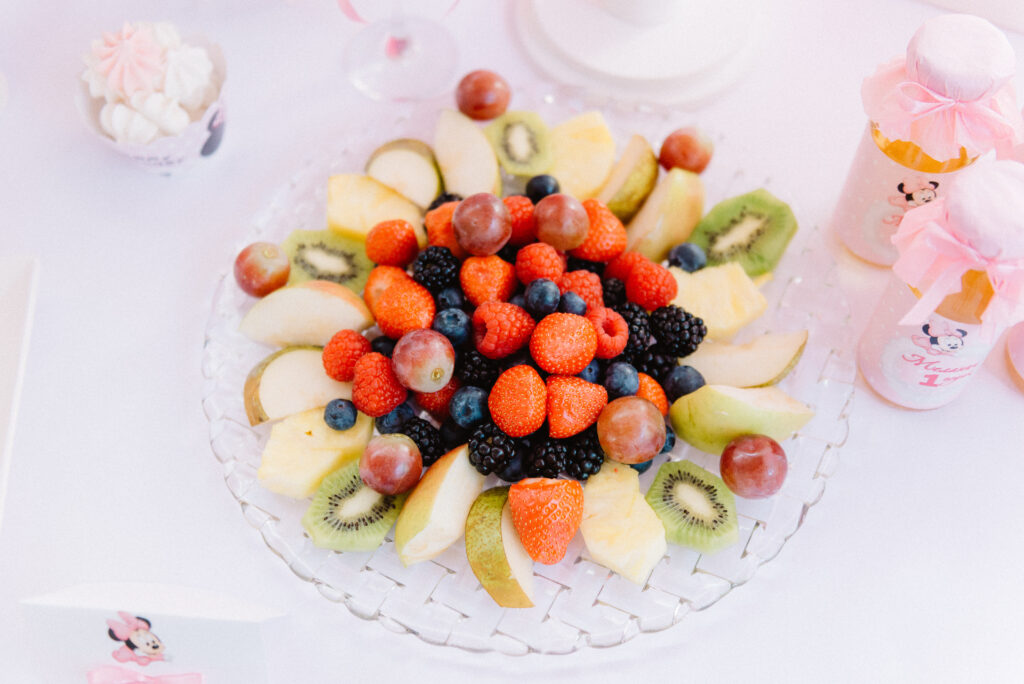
left=597, top=396, right=666, bottom=464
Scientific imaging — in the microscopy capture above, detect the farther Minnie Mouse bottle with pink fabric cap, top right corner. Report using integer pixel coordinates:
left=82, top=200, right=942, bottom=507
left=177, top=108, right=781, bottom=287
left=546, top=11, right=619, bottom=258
left=833, top=14, right=1024, bottom=266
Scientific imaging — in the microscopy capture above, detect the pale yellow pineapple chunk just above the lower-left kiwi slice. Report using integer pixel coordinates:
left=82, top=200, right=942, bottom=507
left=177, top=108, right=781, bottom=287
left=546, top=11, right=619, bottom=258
left=256, top=409, right=374, bottom=499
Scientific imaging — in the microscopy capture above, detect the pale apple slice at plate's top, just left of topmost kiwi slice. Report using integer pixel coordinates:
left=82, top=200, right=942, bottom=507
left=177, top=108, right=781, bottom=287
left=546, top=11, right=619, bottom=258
left=434, top=110, right=502, bottom=198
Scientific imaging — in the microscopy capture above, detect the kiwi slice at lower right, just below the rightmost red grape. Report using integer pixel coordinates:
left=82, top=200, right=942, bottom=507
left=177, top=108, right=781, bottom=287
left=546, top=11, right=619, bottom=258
left=646, top=461, right=739, bottom=553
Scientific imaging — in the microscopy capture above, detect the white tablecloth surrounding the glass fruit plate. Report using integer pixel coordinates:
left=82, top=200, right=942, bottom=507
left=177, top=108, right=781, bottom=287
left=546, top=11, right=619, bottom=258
left=0, top=0, right=1024, bottom=683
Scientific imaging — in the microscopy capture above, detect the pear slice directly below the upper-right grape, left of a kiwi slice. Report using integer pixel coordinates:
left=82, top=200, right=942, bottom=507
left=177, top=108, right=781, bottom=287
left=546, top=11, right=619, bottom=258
left=626, top=169, right=705, bottom=262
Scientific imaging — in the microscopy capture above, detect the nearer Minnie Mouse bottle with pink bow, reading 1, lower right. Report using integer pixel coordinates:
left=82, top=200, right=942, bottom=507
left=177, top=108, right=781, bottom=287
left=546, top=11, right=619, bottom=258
left=857, top=160, right=1024, bottom=409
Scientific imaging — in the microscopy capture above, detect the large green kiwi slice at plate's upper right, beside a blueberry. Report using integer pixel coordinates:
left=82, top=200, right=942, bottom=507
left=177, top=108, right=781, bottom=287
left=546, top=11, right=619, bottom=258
left=688, top=189, right=797, bottom=277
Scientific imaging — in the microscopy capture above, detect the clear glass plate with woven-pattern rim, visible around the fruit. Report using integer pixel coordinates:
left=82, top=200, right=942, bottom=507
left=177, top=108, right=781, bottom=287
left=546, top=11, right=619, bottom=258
left=203, top=86, right=856, bottom=654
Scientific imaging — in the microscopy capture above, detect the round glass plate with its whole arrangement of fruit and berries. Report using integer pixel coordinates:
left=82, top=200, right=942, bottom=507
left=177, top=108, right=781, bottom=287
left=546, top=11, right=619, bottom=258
left=203, top=73, right=855, bottom=654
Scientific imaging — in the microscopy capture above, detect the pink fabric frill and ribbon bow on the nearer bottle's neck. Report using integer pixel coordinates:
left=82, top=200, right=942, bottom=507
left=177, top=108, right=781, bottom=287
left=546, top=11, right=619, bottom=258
left=892, top=198, right=1024, bottom=340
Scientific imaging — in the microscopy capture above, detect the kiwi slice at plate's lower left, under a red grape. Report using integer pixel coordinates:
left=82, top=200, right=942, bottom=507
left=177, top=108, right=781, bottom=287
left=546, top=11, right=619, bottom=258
left=302, top=459, right=406, bottom=551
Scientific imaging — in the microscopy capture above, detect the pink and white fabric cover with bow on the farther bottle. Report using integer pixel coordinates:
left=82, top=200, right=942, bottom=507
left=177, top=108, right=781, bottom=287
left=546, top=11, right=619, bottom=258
left=861, top=14, right=1024, bottom=160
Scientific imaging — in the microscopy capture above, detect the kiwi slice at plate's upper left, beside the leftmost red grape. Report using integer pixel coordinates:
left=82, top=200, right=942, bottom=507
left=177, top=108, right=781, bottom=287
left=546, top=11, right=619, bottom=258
left=281, top=230, right=374, bottom=294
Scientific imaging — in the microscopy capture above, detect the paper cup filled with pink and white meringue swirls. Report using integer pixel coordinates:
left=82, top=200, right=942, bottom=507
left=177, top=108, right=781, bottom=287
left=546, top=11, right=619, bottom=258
left=79, top=22, right=226, bottom=173
